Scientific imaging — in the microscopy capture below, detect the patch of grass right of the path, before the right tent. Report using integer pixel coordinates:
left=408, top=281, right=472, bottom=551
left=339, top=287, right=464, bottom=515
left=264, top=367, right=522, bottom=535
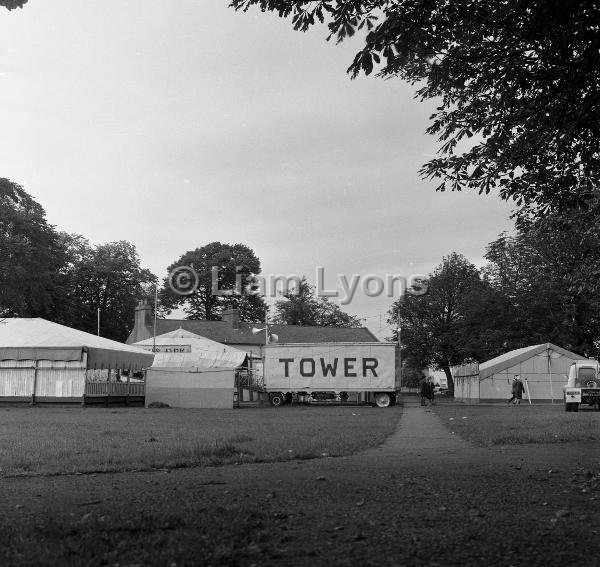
left=433, top=402, right=600, bottom=447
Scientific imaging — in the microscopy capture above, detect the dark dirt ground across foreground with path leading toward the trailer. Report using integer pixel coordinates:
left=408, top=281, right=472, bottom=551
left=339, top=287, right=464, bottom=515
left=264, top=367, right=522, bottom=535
left=0, top=402, right=600, bottom=567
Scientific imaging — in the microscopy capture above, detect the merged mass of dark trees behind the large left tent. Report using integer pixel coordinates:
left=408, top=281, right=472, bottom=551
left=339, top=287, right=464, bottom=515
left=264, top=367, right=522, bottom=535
left=0, top=179, right=156, bottom=341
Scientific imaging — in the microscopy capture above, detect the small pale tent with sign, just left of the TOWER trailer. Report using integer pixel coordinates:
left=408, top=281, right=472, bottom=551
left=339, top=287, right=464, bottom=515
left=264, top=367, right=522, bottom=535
left=141, top=329, right=247, bottom=408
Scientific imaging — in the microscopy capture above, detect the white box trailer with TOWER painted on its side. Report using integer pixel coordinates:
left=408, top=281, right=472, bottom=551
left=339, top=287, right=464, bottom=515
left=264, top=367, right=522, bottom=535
left=263, top=343, right=400, bottom=407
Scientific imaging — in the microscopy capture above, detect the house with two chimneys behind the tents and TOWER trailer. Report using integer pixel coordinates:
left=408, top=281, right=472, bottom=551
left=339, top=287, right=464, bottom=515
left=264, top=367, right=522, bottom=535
left=127, top=302, right=379, bottom=358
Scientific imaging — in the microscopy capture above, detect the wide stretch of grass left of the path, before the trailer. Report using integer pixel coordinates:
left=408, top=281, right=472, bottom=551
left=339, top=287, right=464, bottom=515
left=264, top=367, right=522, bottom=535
left=0, top=407, right=401, bottom=476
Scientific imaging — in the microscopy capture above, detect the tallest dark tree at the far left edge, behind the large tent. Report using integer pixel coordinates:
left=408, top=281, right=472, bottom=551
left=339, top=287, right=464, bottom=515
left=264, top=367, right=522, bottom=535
left=0, top=178, right=64, bottom=318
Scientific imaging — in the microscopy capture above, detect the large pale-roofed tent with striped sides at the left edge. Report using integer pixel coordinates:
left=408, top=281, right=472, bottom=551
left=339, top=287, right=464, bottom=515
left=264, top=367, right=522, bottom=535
left=0, top=318, right=154, bottom=402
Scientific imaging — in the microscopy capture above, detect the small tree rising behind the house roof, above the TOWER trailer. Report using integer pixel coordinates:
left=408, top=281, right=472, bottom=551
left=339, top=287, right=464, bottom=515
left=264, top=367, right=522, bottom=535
left=275, top=276, right=362, bottom=327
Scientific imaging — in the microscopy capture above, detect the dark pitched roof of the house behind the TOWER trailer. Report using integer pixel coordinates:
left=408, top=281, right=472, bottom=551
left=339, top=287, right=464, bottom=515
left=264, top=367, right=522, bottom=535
left=132, top=319, right=379, bottom=345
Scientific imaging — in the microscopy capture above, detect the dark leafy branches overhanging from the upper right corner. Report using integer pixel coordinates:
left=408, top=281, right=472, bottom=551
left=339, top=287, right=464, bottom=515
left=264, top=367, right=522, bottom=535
left=231, top=0, right=600, bottom=219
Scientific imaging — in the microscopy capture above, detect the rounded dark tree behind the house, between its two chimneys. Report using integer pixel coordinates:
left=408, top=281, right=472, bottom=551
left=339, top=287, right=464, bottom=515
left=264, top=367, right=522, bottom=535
left=160, top=242, right=266, bottom=322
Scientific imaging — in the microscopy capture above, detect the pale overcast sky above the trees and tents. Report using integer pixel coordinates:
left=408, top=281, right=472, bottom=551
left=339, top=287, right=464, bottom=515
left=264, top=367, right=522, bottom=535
left=0, top=0, right=512, bottom=336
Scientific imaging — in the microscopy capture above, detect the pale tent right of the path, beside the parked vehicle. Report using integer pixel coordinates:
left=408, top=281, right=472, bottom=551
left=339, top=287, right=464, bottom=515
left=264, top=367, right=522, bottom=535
left=452, top=343, right=584, bottom=403
